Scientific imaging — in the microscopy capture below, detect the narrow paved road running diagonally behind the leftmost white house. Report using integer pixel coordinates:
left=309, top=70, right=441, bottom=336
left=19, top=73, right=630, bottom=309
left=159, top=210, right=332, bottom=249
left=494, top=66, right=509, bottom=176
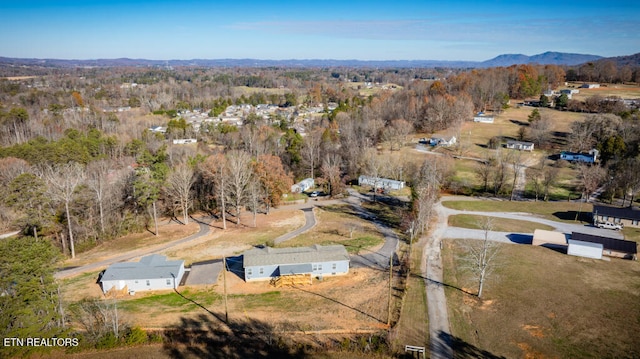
left=54, top=218, right=210, bottom=279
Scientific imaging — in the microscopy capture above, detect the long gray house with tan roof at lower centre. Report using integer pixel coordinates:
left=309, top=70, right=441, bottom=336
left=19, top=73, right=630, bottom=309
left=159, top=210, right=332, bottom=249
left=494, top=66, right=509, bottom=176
left=243, top=244, right=349, bottom=282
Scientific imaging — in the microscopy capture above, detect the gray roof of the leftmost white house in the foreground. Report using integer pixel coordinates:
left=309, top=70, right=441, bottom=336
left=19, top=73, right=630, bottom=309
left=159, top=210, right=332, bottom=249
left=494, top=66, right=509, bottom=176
left=100, top=254, right=184, bottom=282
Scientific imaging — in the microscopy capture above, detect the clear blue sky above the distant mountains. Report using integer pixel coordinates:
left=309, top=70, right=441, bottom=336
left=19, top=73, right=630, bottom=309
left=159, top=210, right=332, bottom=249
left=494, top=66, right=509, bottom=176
left=0, top=0, right=640, bottom=61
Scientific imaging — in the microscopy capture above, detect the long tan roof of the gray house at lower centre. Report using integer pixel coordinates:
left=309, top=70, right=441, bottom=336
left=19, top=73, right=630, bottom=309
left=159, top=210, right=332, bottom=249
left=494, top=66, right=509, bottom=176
left=243, top=244, right=349, bottom=268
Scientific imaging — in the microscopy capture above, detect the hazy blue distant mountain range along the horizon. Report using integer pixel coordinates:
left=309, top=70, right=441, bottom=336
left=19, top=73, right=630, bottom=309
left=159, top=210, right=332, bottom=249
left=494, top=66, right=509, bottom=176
left=0, top=52, right=640, bottom=68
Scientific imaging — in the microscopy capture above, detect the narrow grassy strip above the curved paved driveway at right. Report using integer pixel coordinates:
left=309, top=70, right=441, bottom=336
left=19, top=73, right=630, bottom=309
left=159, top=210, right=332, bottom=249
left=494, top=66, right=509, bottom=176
left=442, top=200, right=593, bottom=223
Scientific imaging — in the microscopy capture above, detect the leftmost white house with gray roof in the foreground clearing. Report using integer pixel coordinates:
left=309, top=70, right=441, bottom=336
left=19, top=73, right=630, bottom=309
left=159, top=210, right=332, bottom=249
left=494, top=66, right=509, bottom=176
left=100, top=254, right=184, bottom=293
